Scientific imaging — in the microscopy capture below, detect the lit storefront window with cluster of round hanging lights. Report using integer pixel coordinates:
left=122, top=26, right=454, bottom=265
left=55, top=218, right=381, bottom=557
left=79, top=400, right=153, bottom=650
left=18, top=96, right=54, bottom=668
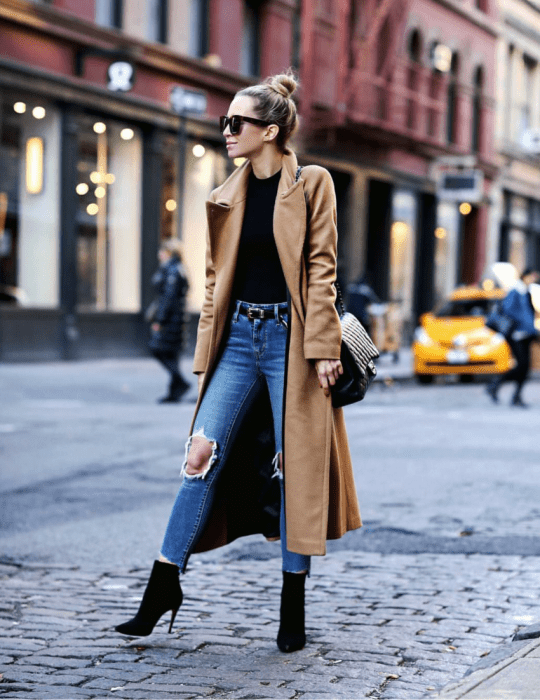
left=73, top=115, right=142, bottom=312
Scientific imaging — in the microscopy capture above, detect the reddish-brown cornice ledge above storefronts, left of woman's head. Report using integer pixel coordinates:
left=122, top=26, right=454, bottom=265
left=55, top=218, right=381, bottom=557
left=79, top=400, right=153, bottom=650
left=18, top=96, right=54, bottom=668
left=0, top=0, right=251, bottom=95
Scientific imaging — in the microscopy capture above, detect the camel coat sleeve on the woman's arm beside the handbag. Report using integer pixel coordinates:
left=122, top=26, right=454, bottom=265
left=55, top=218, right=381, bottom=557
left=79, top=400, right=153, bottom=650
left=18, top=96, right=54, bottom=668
left=304, top=166, right=341, bottom=360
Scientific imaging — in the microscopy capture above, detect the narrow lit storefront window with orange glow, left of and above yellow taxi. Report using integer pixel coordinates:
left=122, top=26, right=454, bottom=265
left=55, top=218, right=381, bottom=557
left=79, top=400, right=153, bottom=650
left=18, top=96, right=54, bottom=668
left=389, top=190, right=417, bottom=318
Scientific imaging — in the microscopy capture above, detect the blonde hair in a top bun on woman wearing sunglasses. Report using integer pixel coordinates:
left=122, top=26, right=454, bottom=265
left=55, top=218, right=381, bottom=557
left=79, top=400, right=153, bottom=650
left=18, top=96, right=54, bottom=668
left=236, top=68, right=299, bottom=150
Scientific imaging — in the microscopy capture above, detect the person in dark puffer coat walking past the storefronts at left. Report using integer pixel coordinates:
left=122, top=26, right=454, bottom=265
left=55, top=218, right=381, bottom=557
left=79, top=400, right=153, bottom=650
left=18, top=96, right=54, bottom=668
left=148, top=238, right=191, bottom=403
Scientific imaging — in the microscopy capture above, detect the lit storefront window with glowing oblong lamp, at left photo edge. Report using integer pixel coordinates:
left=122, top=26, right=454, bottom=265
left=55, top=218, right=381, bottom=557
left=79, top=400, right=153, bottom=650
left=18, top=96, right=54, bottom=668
left=0, top=91, right=60, bottom=307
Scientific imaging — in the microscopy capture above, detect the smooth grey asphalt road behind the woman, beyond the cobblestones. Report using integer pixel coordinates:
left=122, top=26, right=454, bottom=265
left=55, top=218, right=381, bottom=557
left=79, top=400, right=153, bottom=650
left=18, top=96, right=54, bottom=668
left=0, top=360, right=540, bottom=568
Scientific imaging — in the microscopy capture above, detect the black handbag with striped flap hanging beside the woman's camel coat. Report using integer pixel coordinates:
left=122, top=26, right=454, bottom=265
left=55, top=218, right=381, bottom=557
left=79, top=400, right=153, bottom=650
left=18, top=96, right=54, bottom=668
left=296, top=166, right=379, bottom=408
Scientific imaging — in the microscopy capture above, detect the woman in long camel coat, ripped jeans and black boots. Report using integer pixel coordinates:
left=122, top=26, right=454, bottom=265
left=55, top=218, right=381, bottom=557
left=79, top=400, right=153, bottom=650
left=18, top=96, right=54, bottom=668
left=116, top=71, right=361, bottom=652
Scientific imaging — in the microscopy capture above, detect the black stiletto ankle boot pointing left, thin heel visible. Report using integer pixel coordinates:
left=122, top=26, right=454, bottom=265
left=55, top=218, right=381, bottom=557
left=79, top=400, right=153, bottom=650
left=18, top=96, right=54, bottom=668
left=115, top=561, right=182, bottom=637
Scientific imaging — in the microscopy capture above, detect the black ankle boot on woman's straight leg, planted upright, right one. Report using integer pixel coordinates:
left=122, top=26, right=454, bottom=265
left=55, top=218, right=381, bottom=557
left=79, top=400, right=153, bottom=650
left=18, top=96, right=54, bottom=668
left=277, top=571, right=306, bottom=652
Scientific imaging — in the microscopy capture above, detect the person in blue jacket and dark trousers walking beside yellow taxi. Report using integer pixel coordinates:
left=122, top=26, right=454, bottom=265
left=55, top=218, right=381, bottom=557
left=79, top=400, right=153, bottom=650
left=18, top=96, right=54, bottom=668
left=487, top=268, right=540, bottom=408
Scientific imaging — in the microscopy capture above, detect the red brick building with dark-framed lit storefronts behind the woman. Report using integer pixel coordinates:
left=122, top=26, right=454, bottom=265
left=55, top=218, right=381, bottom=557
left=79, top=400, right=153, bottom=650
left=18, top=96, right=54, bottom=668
left=0, top=0, right=497, bottom=360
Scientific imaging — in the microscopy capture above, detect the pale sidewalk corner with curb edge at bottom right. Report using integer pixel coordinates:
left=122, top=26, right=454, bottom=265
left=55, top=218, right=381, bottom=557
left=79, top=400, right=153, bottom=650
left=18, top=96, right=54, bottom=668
left=429, top=625, right=540, bottom=700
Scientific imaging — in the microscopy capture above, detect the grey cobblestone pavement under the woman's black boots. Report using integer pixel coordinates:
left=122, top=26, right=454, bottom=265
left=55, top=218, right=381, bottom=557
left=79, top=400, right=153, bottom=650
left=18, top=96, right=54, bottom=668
left=0, top=551, right=540, bottom=700
